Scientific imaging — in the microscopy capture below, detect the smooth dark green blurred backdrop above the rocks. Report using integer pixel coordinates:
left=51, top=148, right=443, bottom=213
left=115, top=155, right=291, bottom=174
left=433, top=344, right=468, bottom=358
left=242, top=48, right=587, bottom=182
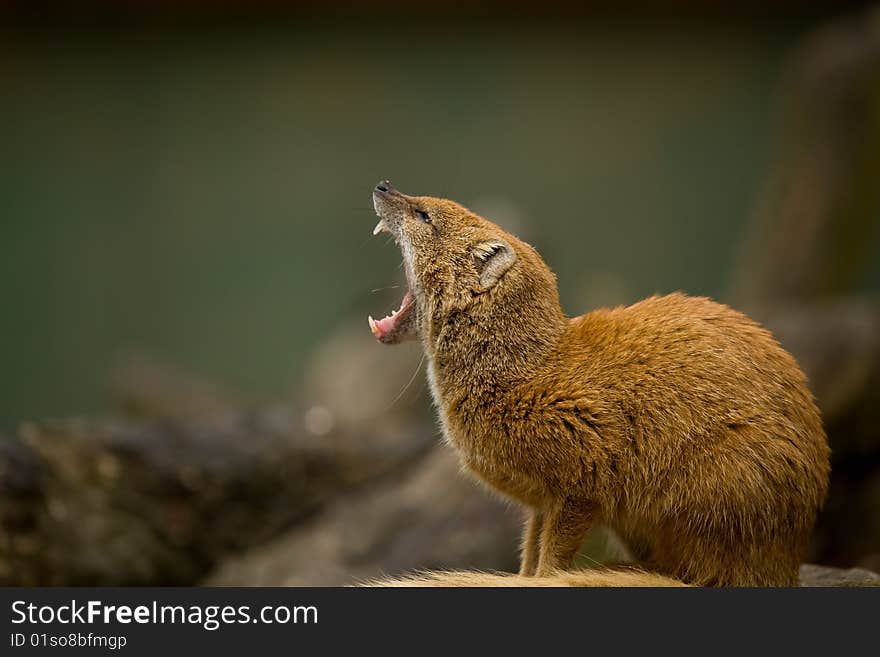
left=0, top=18, right=878, bottom=424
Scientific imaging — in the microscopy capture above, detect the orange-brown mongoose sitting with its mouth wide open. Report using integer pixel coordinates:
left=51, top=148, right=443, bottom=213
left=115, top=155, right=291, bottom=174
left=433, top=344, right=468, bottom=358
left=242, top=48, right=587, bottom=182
left=370, top=181, right=829, bottom=586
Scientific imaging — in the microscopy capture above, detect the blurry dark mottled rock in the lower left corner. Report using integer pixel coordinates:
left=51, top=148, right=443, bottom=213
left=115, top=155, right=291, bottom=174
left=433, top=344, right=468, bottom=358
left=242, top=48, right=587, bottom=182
left=0, top=408, right=433, bottom=585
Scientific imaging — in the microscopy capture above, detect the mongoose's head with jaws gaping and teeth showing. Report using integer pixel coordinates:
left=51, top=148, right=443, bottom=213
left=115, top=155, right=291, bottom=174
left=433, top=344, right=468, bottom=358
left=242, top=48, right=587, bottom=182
left=369, top=180, right=561, bottom=344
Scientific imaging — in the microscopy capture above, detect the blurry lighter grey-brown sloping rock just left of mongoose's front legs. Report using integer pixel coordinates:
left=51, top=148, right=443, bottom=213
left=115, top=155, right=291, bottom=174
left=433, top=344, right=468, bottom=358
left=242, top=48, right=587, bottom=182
left=206, top=449, right=521, bottom=586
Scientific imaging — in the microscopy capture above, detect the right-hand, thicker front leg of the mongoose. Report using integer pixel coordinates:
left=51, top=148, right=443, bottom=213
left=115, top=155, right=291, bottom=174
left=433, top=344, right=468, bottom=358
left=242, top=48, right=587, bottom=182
left=536, top=500, right=593, bottom=577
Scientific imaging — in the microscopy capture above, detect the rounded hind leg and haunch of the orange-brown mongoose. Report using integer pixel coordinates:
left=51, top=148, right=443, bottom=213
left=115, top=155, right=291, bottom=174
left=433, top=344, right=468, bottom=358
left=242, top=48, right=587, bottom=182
left=641, top=421, right=824, bottom=586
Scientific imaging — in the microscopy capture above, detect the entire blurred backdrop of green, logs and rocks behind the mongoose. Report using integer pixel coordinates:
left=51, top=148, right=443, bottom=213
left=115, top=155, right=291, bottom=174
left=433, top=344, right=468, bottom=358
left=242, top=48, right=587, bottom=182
left=0, top=0, right=880, bottom=586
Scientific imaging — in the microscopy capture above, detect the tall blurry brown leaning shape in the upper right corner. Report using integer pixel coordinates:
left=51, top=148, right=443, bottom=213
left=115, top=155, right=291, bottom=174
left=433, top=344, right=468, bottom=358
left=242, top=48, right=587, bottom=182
left=735, top=7, right=880, bottom=310
